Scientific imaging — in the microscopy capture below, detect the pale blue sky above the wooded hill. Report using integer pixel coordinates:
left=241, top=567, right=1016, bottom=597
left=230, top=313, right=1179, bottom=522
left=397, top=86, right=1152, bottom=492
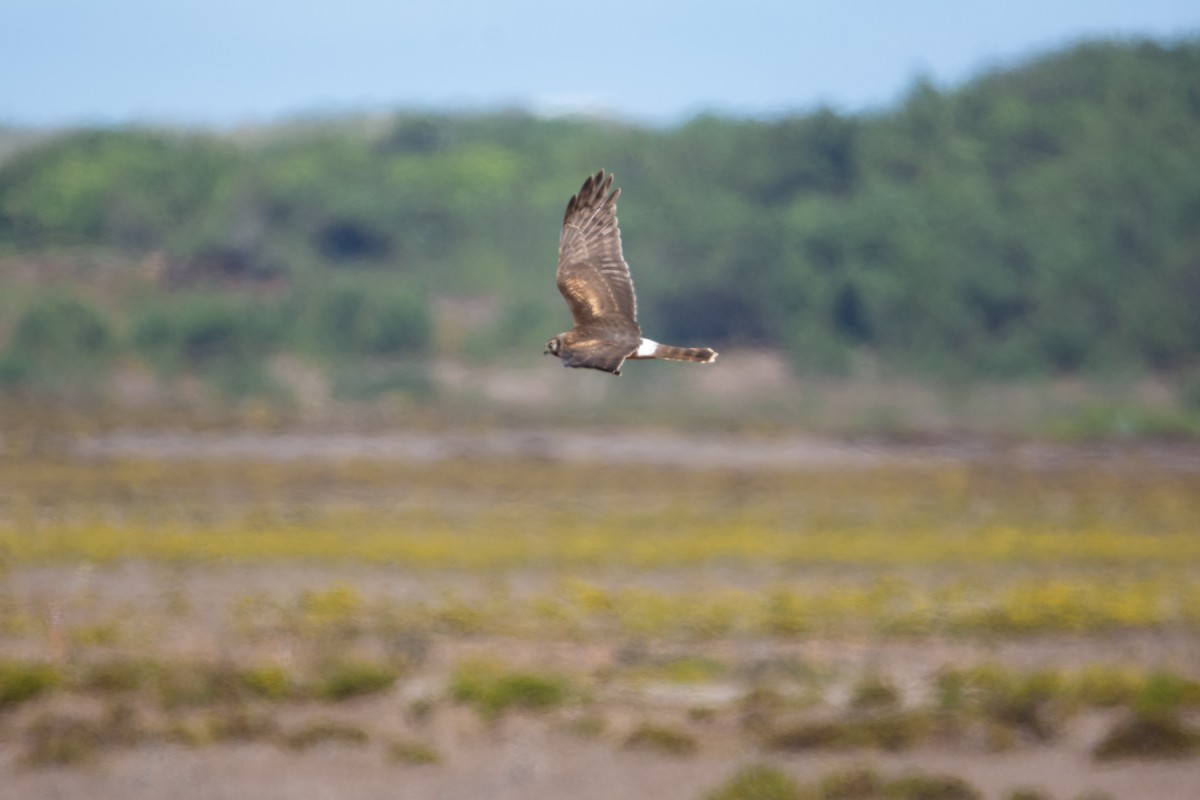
left=0, top=0, right=1200, bottom=126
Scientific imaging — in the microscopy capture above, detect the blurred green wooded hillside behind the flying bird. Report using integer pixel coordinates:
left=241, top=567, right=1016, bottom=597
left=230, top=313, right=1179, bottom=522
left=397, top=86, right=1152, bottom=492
left=0, top=40, right=1200, bottom=402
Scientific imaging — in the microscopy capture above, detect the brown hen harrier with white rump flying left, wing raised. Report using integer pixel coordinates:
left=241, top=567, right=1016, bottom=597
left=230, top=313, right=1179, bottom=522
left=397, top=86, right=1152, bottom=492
left=546, top=169, right=716, bottom=375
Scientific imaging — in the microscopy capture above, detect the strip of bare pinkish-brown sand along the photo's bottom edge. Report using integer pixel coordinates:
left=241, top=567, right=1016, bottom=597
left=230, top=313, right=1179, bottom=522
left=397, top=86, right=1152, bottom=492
left=0, top=717, right=1200, bottom=800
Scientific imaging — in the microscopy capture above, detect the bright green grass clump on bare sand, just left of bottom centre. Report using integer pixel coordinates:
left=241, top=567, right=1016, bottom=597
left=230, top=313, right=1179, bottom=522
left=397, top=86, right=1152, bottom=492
left=450, top=661, right=577, bottom=720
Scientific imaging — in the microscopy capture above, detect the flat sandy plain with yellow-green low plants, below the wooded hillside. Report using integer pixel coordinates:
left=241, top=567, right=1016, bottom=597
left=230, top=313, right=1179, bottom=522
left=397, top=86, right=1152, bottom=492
left=0, top=427, right=1200, bottom=800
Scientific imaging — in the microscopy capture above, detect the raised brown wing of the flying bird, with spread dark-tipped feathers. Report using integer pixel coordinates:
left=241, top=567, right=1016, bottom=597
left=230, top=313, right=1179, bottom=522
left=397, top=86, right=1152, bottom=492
left=558, top=169, right=641, bottom=335
